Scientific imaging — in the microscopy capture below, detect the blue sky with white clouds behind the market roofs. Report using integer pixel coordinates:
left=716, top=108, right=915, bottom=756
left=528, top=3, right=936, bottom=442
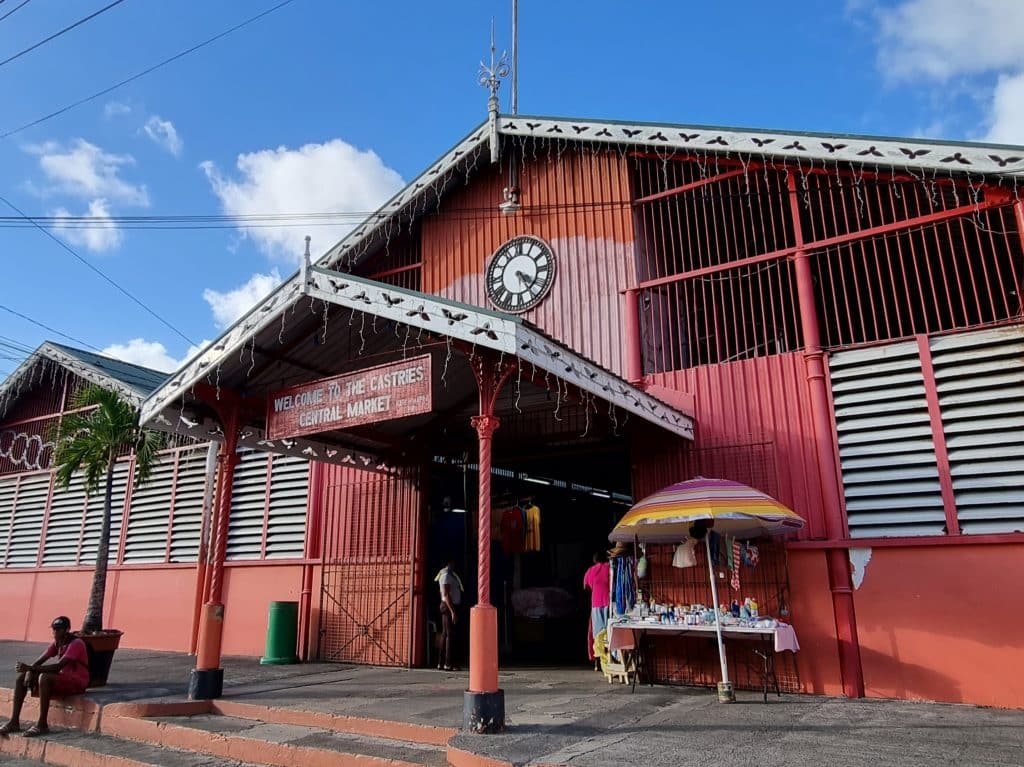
left=0, top=0, right=1024, bottom=376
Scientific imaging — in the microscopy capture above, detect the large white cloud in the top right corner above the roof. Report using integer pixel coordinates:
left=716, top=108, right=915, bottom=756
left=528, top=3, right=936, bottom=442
left=860, top=0, right=1024, bottom=143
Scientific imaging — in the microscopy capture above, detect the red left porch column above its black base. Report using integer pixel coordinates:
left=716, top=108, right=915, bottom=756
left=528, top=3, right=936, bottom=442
left=196, top=403, right=239, bottom=671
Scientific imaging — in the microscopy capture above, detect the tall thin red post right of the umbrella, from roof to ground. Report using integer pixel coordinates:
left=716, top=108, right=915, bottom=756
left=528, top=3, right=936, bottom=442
left=788, top=174, right=864, bottom=697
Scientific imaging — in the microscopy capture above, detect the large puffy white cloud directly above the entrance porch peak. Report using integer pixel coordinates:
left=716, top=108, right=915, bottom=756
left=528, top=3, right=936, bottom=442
left=200, top=138, right=403, bottom=262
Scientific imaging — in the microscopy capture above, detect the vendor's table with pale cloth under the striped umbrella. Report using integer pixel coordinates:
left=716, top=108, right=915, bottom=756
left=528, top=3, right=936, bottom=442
left=608, top=621, right=800, bottom=702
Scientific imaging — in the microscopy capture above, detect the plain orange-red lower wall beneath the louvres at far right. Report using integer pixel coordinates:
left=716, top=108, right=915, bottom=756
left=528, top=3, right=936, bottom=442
left=854, top=544, right=1024, bottom=708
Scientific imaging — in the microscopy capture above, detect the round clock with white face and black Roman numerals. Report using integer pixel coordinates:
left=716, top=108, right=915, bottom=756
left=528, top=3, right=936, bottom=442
left=486, top=237, right=555, bottom=314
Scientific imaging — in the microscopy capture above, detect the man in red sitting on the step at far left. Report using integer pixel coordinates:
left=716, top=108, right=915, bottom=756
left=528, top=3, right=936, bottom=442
left=0, top=615, right=89, bottom=737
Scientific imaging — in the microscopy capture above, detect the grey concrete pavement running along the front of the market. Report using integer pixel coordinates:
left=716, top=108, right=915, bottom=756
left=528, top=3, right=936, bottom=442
left=0, top=642, right=1024, bottom=767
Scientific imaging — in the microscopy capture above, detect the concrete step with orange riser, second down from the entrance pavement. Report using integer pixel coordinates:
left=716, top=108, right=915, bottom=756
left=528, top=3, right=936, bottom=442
left=103, top=713, right=447, bottom=767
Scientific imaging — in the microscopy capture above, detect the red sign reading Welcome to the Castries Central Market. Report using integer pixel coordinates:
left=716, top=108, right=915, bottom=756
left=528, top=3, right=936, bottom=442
left=266, top=354, right=433, bottom=439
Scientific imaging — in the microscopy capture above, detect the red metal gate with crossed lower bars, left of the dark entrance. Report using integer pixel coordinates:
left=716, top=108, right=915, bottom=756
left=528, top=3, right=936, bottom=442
left=317, top=469, right=422, bottom=666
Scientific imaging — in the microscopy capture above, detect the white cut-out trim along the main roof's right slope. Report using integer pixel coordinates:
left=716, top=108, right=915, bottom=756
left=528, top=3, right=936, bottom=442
left=499, top=115, right=1024, bottom=177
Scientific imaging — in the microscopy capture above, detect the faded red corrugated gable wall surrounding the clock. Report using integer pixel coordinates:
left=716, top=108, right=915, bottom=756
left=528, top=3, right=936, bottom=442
left=423, top=150, right=636, bottom=373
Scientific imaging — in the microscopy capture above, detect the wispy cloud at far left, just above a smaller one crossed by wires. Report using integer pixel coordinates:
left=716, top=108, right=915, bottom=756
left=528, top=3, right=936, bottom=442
left=26, top=138, right=150, bottom=208
